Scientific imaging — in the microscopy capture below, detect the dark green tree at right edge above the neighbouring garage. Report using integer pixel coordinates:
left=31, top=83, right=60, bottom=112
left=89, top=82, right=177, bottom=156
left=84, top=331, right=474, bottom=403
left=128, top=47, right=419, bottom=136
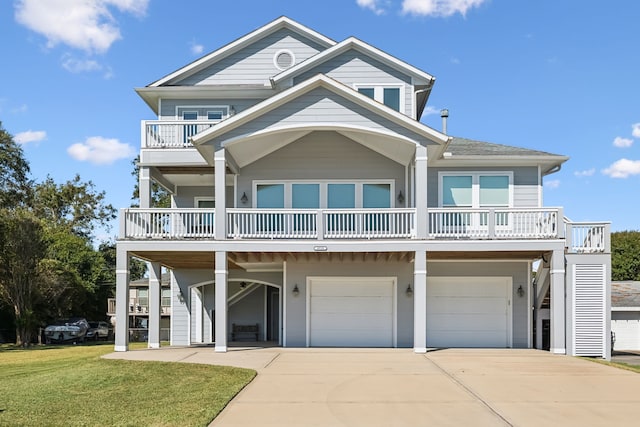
left=611, top=231, right=640, bottom=281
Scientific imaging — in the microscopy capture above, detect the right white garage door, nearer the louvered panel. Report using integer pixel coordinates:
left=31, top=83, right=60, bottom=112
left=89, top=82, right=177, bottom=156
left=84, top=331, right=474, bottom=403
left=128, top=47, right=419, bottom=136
left=427, top=277, right=511, bottom=348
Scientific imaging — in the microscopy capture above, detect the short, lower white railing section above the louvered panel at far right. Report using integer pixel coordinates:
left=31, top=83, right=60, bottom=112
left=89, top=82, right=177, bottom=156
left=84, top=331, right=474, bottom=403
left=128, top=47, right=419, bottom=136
left=565, top=218, right=611, bottom=253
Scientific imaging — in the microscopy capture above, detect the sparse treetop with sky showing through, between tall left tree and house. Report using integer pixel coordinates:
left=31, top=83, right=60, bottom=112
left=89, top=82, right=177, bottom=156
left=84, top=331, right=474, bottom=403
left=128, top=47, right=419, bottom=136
left=33, top=175, right=116, bottom=239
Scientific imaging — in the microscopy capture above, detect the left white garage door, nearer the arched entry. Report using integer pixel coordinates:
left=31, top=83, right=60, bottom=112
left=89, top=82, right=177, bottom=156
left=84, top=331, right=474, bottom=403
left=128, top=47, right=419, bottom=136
left=307, top=277, right=395, bottom=347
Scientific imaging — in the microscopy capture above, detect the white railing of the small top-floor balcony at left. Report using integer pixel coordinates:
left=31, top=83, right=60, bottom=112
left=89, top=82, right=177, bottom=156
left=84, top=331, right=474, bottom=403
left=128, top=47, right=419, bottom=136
left=141, top=120, right=218, bottom=148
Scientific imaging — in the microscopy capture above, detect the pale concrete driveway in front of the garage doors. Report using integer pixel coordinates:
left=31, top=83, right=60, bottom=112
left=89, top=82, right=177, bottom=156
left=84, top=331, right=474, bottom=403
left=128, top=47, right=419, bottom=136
left=108, top=348, right=640, bottom=427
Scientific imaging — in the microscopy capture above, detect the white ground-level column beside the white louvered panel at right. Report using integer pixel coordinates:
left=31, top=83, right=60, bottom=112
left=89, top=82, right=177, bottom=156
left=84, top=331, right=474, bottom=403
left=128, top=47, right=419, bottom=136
left=550, top=250, right=567, bottom=354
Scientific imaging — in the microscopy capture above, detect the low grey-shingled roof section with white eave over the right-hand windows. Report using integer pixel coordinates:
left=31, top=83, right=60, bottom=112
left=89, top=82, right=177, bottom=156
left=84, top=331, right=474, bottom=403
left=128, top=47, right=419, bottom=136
left=436, top=137, right=569, bottom=175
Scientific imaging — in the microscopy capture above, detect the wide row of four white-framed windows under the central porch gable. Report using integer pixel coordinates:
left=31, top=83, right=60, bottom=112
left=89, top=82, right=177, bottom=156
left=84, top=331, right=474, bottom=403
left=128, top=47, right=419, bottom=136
left=254, top=180, right=394, bottom=209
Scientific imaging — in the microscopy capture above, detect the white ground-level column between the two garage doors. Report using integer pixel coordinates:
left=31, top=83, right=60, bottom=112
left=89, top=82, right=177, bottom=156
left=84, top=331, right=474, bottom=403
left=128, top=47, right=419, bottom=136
left=413, top=251, right=427, bottom=353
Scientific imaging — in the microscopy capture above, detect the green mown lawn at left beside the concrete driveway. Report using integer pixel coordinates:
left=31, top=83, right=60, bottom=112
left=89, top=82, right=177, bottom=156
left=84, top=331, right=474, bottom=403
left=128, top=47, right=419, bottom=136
left=0, top=344, right=256, bottom=426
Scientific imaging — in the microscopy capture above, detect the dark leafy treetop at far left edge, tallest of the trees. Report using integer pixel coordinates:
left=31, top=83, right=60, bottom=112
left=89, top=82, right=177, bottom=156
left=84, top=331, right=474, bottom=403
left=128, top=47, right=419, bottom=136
left=0, top=122, right=32, bottom=209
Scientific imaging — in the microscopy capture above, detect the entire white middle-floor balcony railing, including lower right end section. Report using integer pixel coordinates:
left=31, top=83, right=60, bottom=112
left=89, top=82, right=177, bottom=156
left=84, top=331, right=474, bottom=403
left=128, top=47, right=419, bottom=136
left=120, top=208, right=610, bottom=253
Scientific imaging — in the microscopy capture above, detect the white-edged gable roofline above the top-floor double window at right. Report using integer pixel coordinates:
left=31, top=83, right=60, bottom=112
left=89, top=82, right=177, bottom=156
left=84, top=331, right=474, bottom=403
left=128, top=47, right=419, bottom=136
left=271, top=37, right=435, bottom=85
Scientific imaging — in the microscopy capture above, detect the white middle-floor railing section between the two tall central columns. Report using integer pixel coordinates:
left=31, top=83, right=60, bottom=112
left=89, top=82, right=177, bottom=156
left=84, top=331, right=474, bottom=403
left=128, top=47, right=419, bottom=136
left=227, top=209, right=415, bottom=240
